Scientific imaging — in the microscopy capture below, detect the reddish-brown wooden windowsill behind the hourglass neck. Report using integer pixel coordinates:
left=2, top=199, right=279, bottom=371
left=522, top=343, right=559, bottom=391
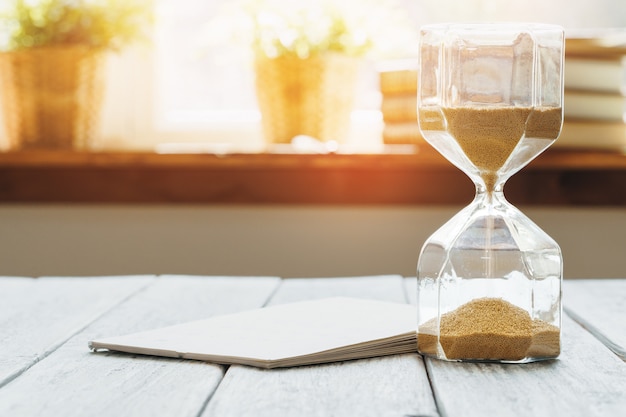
left=0, top=147, right=626, bottom=206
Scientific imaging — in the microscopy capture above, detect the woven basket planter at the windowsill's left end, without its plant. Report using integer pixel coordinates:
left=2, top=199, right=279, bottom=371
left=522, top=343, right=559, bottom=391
left=0, top=46, right=105, bottom=150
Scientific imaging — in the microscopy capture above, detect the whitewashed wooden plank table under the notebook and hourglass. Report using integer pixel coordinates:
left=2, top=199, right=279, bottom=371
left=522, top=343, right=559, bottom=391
left=0, top=276, right=626, bottom=417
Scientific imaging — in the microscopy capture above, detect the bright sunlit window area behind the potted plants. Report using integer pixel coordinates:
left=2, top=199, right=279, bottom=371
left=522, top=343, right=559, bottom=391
left=0, top=0, right=626, bottom=151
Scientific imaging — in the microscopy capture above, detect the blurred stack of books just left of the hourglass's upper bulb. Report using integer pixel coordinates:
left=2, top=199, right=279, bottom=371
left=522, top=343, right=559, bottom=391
left=378, top=61, right=423, bottom=145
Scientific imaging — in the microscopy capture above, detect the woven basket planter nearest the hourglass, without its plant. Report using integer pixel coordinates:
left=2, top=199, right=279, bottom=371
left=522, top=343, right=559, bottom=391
left=255, top=54, right=359, bottom=143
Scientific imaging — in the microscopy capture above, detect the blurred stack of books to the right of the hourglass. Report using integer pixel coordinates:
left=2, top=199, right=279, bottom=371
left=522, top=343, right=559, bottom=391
left=554, top=31, right=626, bottom=151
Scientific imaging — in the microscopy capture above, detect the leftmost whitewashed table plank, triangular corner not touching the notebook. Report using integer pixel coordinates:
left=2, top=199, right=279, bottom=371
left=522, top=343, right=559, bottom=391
left=0, top=276, right=155, bottom=387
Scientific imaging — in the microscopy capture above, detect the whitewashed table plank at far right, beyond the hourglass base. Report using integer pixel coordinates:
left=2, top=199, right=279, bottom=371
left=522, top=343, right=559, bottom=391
left=563, top=279, right=626, bottom=360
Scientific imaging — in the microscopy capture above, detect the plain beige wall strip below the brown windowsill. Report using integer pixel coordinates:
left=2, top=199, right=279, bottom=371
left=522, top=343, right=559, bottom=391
left=0, top=205, right=626, bottom=278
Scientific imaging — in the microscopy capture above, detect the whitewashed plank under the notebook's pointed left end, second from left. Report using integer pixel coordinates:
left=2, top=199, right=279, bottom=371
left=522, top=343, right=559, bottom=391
left=0, top=276, right=279, bottom=417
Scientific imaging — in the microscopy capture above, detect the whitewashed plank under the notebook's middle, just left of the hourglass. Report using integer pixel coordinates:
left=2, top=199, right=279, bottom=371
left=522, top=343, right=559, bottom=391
left=203, top=276, right=438, bottom=417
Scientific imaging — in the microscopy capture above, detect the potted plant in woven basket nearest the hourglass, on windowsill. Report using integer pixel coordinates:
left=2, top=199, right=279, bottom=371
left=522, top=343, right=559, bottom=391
left=213, top=0, right=408, bottom=143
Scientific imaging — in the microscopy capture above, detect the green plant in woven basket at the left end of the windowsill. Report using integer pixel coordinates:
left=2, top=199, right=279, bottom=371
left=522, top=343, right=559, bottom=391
left=0, top=0, right=150, bottom=149
